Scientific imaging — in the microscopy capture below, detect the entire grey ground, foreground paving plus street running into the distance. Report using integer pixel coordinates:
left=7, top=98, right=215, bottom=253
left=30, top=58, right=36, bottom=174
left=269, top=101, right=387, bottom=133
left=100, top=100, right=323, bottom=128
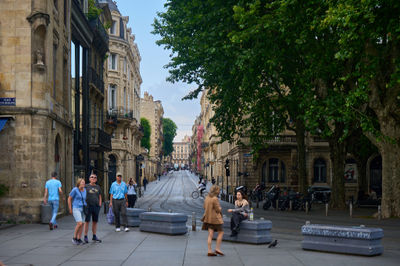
left=0, top=171, right=400, bottom=266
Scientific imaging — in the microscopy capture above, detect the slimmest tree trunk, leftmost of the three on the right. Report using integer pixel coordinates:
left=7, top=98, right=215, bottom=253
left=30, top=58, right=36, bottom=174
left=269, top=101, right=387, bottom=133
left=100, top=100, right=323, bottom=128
left=296, top=120, right=308, bottom=194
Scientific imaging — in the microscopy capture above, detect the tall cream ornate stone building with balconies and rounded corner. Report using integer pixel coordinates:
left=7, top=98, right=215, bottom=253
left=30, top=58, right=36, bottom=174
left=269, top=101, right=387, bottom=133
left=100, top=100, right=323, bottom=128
left=105, top=0, right=143, bottom=195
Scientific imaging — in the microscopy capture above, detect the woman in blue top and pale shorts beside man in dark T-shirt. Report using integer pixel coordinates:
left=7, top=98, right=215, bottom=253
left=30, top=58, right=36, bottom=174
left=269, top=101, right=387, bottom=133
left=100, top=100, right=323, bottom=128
left=68, top=178, right=86, bottom=245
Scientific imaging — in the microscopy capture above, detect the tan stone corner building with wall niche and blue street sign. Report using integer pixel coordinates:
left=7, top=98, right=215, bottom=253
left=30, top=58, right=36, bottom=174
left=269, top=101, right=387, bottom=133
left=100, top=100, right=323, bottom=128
left=0, top=0, right=111, bottom=221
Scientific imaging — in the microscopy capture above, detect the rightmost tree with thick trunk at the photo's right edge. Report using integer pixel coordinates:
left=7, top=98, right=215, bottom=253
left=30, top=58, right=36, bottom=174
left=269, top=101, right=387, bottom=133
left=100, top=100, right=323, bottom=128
left=323, top=0, right=400, bottom=218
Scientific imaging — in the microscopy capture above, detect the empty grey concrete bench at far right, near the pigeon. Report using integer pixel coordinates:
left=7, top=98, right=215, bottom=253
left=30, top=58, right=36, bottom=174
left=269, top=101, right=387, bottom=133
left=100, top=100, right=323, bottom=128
left=301, top=224, right=383, bottom=256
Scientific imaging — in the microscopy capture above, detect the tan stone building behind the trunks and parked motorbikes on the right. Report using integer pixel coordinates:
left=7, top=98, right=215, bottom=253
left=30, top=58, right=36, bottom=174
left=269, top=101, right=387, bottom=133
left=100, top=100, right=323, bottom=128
left=191, top=91, right=382, bottom=199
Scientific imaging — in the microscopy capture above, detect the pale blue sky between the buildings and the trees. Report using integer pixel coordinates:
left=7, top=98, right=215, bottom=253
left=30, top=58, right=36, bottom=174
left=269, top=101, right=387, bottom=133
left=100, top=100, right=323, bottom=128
left=113, top=0, right=200, bottom=142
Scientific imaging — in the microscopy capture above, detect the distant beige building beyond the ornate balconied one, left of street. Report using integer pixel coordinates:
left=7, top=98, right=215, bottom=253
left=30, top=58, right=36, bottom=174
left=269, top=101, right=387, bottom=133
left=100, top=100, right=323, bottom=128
left=140, top=92, right=164, bottom=181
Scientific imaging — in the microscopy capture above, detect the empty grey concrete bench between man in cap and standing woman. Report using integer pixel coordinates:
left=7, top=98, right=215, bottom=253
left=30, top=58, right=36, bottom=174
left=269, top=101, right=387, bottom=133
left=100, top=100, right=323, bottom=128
left=139, top=212, right=187, bottom=235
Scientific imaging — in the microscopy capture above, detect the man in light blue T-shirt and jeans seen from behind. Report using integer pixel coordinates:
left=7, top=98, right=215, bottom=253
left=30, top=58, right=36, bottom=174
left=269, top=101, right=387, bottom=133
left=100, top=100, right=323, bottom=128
left=43, top=172, right=62, bottom=230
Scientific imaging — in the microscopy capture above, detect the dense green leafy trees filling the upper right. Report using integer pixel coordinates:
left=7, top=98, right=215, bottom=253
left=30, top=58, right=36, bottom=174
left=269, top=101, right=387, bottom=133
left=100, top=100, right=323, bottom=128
left=154, top=0, right=400, bottom=217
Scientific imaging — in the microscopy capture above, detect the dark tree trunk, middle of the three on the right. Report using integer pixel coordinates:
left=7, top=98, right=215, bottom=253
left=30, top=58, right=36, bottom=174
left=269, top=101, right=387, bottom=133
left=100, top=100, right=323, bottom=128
left=329, top=123, right=346, bottom=209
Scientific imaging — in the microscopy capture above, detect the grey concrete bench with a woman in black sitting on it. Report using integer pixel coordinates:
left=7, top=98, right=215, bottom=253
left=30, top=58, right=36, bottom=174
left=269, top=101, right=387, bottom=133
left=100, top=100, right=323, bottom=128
left=214, top=218, right=272, bottom=244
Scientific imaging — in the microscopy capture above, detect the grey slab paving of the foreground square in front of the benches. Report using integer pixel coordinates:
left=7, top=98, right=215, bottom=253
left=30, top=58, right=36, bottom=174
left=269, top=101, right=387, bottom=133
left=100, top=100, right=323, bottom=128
left=0, top=210, right=400, bottom=266
